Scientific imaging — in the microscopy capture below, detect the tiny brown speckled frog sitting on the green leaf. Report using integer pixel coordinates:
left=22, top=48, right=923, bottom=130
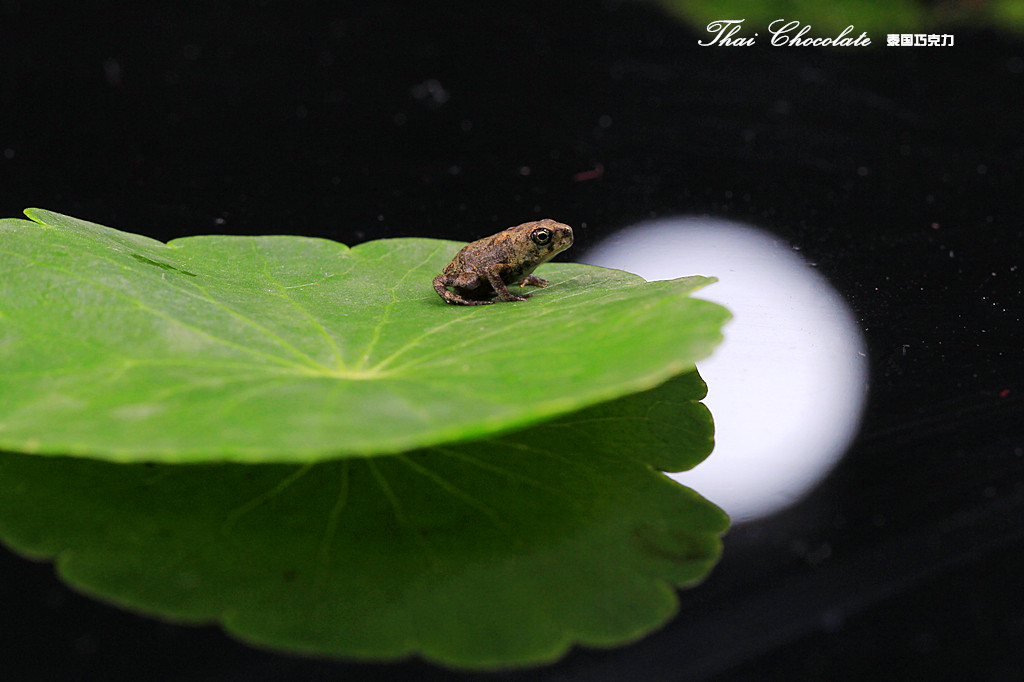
left=434, top=219, right=572, bottom=305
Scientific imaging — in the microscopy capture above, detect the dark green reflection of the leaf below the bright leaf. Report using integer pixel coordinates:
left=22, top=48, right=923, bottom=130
left=0, top=373, right=727, bottom=668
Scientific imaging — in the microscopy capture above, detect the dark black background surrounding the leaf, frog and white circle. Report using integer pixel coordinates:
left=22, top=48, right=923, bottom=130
left=0, top=1, right=1024, bottom=680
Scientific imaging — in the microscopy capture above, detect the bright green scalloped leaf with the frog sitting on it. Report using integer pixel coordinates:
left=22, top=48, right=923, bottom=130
left=0, top=209, right=728, bottom=462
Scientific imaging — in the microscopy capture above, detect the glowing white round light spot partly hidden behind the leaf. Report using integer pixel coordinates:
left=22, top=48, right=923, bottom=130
left=583, top=218, right=867, bottom=522
